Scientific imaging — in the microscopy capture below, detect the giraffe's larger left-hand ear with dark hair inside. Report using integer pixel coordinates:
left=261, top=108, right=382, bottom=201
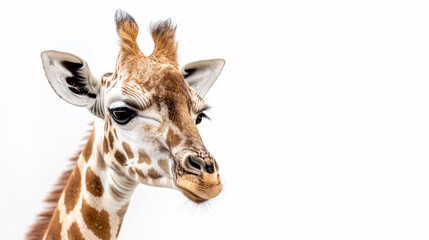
left=41, top=51, right=101, bottom=109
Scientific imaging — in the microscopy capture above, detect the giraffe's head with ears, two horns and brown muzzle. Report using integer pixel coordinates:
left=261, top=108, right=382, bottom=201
left=42, top=10, right=224, bottom=203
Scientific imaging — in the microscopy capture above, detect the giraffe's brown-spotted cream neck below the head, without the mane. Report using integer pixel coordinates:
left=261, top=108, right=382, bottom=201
left=44, top=120, right=137, bottom=240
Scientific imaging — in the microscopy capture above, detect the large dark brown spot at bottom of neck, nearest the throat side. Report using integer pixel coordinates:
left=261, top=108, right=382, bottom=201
left=80, top=199, right=110, bottom=240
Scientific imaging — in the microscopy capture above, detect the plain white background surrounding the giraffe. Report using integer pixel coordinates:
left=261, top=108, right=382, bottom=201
left=0, top=0, right=429, bottom=240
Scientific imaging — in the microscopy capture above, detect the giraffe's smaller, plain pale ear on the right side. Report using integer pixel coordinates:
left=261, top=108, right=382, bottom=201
left=182, top=59, right=225, bottom=98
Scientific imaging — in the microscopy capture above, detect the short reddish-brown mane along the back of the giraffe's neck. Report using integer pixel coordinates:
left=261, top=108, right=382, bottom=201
left=25, top=123, right=93, bottom=240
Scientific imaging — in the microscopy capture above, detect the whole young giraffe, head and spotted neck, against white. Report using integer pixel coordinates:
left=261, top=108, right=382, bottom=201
left=26, top=10, right=225, bottom=240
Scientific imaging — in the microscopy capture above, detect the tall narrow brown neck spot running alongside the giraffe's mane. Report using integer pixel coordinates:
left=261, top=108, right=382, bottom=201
left=64, top=165, right=81, bottom=213
